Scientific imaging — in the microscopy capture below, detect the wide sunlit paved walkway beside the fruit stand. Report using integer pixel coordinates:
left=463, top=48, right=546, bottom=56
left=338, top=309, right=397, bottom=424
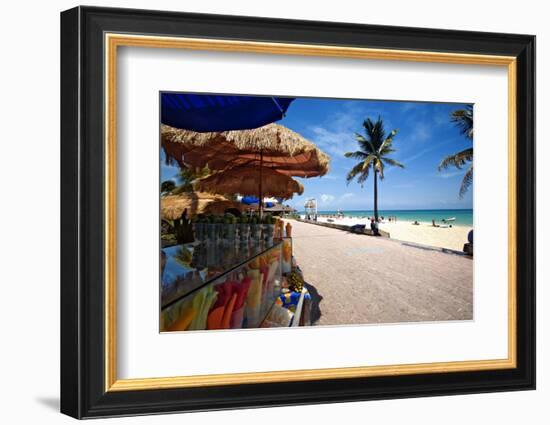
left=291, top=220, right=473, bottom=325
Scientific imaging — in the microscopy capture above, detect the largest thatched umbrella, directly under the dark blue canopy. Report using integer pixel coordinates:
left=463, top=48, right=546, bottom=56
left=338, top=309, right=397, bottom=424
left=161, top=124, right=329, bottom=177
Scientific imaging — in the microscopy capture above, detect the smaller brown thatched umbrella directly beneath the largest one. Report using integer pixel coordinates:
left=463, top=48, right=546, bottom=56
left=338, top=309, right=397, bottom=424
left=194, top=167, right=304, bottom=199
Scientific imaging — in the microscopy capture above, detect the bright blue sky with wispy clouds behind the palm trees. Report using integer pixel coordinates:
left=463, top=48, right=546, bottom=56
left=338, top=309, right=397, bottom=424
left=161, top=98, right=472, bottom=210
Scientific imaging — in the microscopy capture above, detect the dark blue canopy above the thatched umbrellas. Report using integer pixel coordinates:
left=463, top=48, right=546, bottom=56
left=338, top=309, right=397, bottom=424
left=161, top=93, right=294, bottom=133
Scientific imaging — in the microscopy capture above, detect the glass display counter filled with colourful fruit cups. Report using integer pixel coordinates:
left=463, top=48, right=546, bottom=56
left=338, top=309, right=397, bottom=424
left=160, top=238, right=292, bottom=332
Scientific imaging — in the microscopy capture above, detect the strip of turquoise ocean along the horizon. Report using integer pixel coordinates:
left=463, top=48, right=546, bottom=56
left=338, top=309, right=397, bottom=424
left=300, top=209, right=473, bottom=226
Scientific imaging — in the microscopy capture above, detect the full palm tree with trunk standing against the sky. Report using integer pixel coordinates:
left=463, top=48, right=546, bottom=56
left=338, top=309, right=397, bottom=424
left=345, top=117, right=405, bottom=221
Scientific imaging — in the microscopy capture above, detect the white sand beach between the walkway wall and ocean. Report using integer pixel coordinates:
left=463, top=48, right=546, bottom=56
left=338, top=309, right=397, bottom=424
left=310, top=217, right=472, bottom=251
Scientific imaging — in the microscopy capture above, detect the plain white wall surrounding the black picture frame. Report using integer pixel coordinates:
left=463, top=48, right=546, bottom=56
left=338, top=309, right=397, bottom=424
left=0, top=0, right=550, bottom=425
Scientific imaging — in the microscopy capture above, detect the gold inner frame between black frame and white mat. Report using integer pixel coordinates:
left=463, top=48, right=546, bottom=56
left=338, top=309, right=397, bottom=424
left=104, top=33, right=517, bottom=391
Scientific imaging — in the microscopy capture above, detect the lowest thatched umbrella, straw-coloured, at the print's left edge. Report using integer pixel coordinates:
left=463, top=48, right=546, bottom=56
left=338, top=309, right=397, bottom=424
left=160, top=192, right=244, bottom=220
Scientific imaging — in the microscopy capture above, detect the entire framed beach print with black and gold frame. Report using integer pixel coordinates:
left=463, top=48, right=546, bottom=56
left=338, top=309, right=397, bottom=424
left=61, top=7, right=535, bottom=418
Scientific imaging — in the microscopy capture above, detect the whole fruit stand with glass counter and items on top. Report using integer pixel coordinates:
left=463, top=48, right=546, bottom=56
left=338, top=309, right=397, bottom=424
left=160, top=215, right=309, bottom=332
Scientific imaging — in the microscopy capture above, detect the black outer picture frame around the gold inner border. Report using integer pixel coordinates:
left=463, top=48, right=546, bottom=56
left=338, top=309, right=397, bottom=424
left=61, top=7, right=535, bottom=418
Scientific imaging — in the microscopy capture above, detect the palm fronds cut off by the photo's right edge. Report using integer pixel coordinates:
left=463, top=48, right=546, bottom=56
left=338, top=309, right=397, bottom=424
left=438, top=105, right=474, bottom=198
